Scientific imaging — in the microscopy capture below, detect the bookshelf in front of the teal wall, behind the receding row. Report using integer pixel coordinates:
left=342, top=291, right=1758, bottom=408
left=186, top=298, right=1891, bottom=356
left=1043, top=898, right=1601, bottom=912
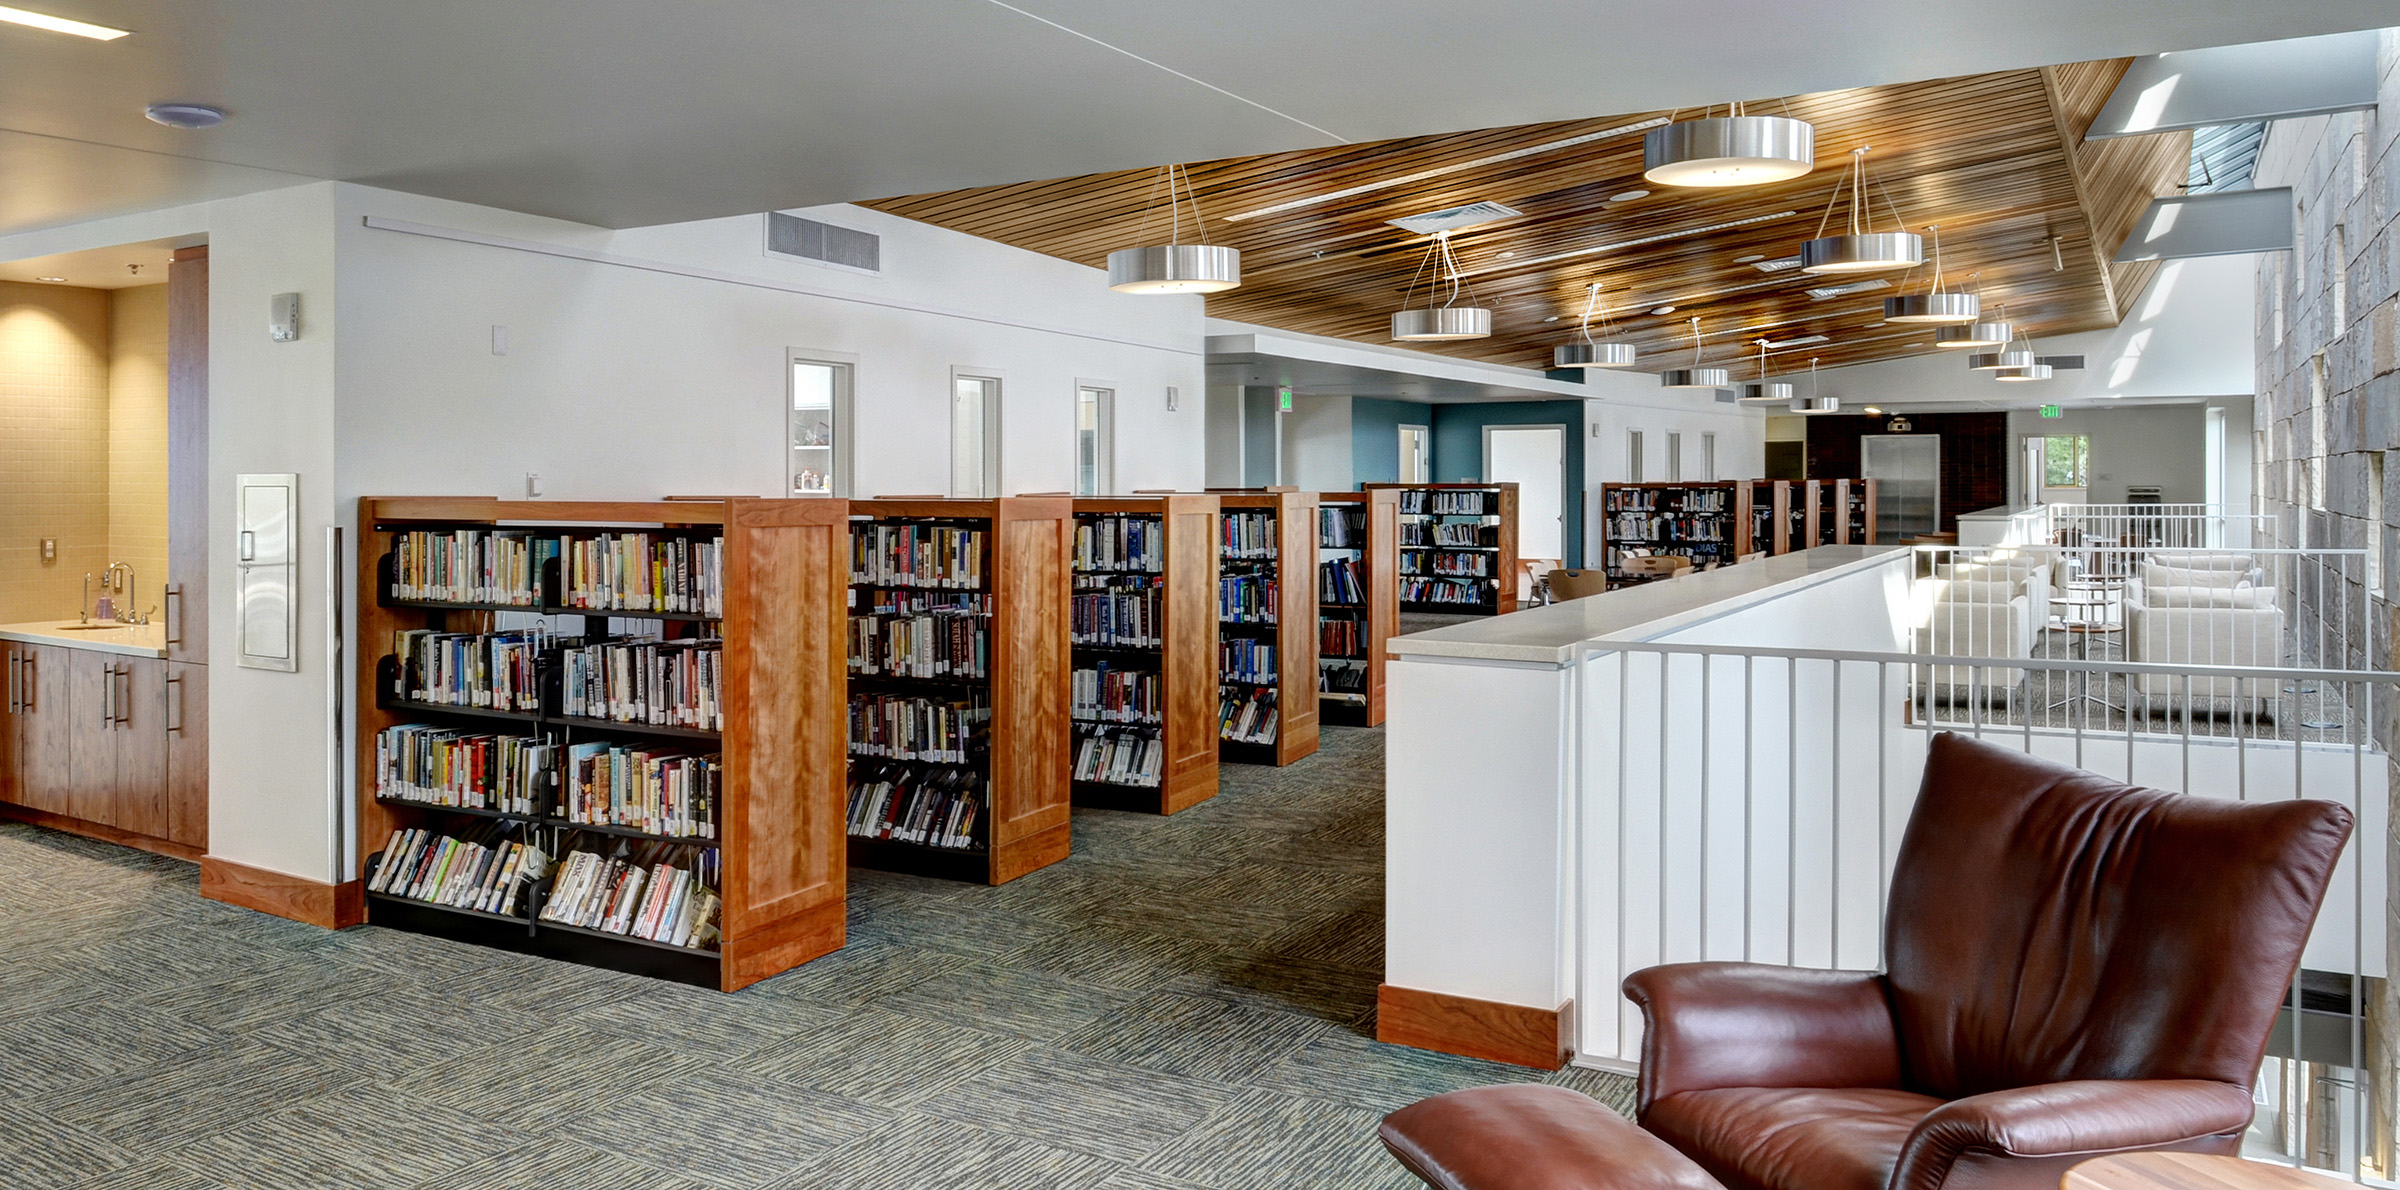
left=1366, top=482, right=1517, bottom=617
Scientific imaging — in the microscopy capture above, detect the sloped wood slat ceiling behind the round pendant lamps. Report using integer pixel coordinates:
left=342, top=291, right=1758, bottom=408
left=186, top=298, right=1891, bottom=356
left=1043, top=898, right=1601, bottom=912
left=864, top=60, right=2189, bottom=377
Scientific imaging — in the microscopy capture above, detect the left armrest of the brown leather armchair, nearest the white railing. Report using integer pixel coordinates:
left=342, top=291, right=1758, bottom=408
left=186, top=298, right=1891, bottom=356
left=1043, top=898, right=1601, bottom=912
left=1625, top=962, right=1901, bottom=1113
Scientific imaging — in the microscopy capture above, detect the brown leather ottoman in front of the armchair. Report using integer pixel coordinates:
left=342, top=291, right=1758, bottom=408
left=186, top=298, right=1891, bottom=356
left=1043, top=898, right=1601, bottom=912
left=1380, top=1082, right=1726, bottom=1190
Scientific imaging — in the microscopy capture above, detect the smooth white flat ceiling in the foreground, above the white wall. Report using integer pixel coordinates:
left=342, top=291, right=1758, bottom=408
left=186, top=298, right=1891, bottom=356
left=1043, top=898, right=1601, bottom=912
left=0, top=0, right=2393, bottom=233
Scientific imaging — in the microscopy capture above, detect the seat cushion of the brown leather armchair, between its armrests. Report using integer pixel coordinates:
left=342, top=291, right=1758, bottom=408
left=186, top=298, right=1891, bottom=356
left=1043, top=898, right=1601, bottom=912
left=1642, top=1087, right=1942, bottom=1190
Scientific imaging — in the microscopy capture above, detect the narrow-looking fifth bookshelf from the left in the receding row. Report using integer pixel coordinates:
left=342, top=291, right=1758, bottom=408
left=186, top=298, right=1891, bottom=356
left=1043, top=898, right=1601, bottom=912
left=1318, top=487, right=1399, bottom=727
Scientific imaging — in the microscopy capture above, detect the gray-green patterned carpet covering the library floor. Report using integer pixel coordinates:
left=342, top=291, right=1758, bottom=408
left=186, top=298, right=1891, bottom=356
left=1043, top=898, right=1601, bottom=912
left=0, top=727, right=1632, bottom=1190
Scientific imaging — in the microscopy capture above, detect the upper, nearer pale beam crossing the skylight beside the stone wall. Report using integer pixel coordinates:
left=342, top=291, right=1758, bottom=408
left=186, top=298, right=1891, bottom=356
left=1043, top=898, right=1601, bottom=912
left=2083, top=31, right=2381, bottom=139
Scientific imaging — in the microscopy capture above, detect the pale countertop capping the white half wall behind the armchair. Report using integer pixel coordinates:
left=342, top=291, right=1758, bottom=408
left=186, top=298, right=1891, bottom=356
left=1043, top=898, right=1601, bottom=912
left=1387, top=545, right=1908, bottom=665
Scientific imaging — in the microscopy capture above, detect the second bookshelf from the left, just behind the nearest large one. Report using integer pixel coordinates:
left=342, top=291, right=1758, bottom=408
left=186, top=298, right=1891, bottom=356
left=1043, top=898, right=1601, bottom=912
left=845, top=497, right=1075, bottom=885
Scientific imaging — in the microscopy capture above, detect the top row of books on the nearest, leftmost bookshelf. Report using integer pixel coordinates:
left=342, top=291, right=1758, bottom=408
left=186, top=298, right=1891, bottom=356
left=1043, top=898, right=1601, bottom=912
left=391, top=528, right=725, bottom=614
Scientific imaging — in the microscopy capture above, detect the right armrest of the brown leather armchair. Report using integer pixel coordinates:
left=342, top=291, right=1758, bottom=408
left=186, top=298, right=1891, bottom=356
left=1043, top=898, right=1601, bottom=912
left=1891, top=1080, right=2251, bottom=1190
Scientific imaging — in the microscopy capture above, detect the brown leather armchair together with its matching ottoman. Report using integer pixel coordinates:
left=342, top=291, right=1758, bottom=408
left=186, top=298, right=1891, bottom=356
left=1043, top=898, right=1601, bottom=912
left=1382, top=734, right=2350, bottom=1190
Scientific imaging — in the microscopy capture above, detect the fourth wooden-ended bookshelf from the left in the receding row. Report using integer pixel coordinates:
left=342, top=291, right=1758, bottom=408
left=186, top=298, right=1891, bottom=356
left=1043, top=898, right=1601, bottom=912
left=1217, top=487, right=1318, bottom=765
